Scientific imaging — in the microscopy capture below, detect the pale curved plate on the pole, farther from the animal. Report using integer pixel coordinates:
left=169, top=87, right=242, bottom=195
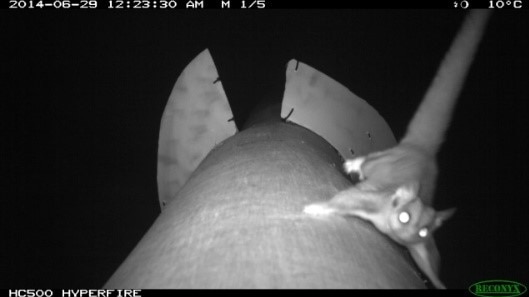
left=158, top=49, right=237, bottom=208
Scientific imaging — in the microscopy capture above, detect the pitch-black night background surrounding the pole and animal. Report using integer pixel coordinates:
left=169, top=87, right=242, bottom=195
left=0, top=10, right=529, bottom=288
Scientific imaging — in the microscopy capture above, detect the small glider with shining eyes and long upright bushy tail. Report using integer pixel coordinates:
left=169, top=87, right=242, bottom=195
left=304, top=10, right=491, bottom=288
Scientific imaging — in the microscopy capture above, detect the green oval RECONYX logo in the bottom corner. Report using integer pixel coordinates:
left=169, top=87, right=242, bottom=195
left=468, top=280, right=527, bottom=297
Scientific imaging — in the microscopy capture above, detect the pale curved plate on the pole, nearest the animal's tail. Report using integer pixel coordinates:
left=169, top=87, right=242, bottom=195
left=281, top=60, right=396, bottom=159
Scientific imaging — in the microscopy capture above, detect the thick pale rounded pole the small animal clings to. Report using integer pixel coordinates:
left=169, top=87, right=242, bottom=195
left=105, top=121, right=424, bottom=288
